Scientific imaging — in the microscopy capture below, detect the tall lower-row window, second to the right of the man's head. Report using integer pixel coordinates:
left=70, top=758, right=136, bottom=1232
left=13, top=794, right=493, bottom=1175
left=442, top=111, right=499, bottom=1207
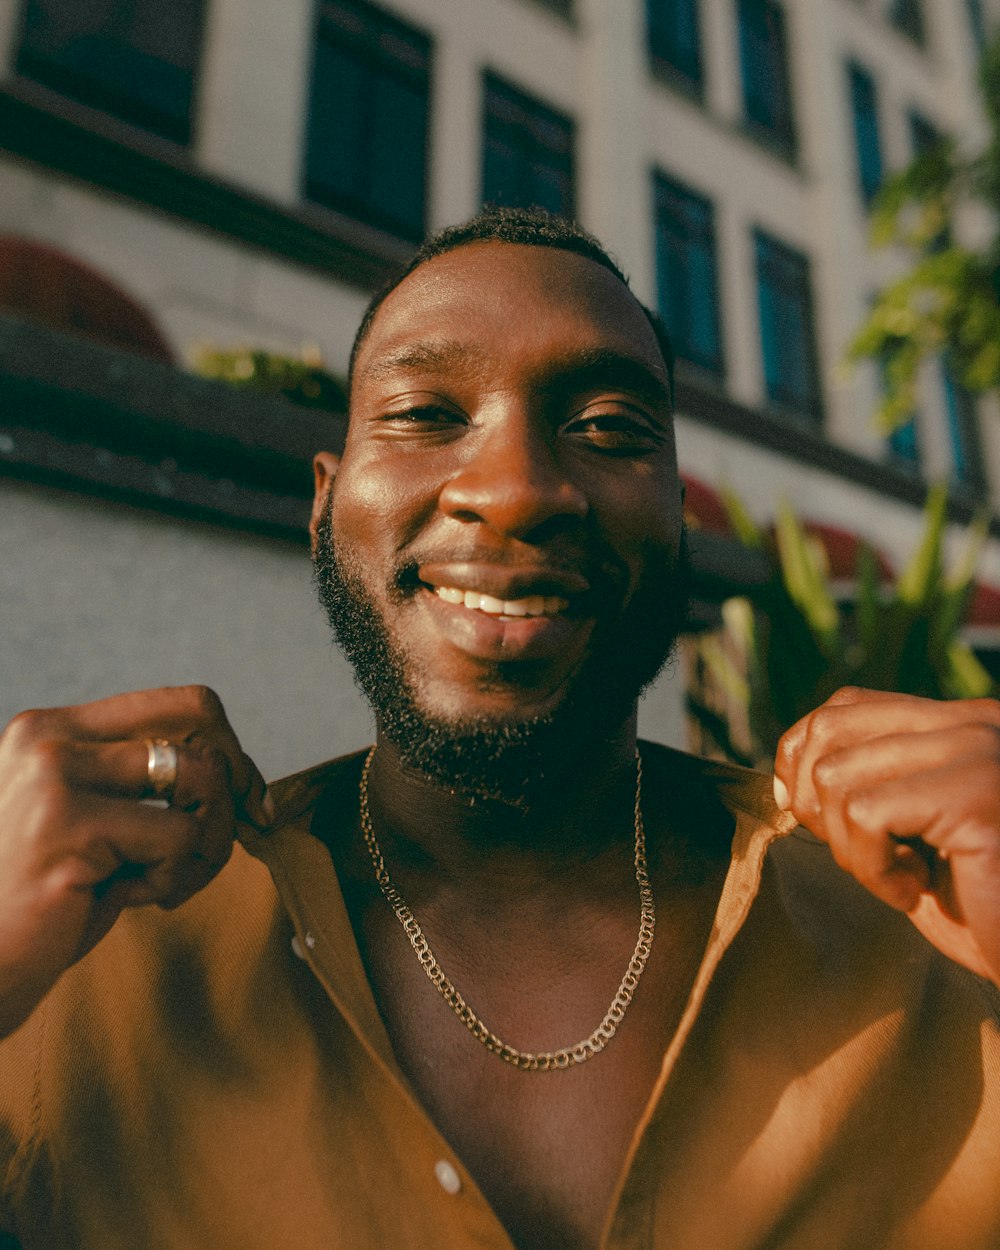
left=754, top=230, right=823, bottom=421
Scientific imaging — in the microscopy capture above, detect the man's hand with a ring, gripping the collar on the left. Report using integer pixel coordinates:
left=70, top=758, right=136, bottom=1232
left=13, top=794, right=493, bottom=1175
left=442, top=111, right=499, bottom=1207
left=0, top=686, right=271, bottom=1036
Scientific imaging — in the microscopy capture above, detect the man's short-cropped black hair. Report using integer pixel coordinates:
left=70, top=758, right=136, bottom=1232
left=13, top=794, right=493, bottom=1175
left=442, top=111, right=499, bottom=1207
left=348, top=205, right=674, bottom=406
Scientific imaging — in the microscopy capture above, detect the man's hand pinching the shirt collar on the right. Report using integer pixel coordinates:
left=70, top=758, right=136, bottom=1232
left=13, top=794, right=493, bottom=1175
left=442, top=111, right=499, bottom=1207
left=775, top=688, right=1000, bottom=985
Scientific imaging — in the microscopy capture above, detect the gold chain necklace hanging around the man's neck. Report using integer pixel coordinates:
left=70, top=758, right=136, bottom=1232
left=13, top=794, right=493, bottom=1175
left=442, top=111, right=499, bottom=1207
left=359, top=746, right=656, bottom=1073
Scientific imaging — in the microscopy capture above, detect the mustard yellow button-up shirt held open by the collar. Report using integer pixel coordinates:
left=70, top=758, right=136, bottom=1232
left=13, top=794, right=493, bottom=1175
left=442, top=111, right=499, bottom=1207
left=0, top=750, right=1000, bottom=1250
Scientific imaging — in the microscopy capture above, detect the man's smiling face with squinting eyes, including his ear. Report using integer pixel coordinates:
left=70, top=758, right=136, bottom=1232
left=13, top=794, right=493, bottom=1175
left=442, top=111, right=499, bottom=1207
left=314, top=243, right=683, bottom=790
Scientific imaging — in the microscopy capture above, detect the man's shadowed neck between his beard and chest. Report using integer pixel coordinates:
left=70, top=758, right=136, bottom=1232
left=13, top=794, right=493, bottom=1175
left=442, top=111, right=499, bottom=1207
left=369, top=716, right=635, bottom=880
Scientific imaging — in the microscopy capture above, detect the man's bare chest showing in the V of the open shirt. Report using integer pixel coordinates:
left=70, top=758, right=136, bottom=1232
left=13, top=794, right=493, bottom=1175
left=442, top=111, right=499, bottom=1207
left=347, top=886, right=714, bottom=1250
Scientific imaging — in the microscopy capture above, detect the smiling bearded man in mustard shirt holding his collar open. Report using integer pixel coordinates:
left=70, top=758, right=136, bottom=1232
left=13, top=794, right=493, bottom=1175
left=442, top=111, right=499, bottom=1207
left=0, top=213, right=1000, bottom=1250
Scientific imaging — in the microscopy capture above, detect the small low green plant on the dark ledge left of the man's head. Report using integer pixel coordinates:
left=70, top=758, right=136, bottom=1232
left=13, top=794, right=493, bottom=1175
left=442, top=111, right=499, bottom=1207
left=191, top=345, right=348, bottom=413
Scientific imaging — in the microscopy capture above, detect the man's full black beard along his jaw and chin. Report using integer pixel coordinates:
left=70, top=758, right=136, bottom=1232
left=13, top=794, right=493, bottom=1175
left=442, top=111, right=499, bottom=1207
left=313, top=500, right=690, bottom=808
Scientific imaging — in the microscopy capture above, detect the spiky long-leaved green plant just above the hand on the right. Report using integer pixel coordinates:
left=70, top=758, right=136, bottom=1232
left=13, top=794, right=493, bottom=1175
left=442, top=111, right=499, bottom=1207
left=689, top=485, right=994, bottom=765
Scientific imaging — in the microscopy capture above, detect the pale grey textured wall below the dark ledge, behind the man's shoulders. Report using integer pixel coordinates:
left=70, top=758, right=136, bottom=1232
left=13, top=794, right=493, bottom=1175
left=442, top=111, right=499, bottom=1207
left=0, top=480, right=683, bottom=778
